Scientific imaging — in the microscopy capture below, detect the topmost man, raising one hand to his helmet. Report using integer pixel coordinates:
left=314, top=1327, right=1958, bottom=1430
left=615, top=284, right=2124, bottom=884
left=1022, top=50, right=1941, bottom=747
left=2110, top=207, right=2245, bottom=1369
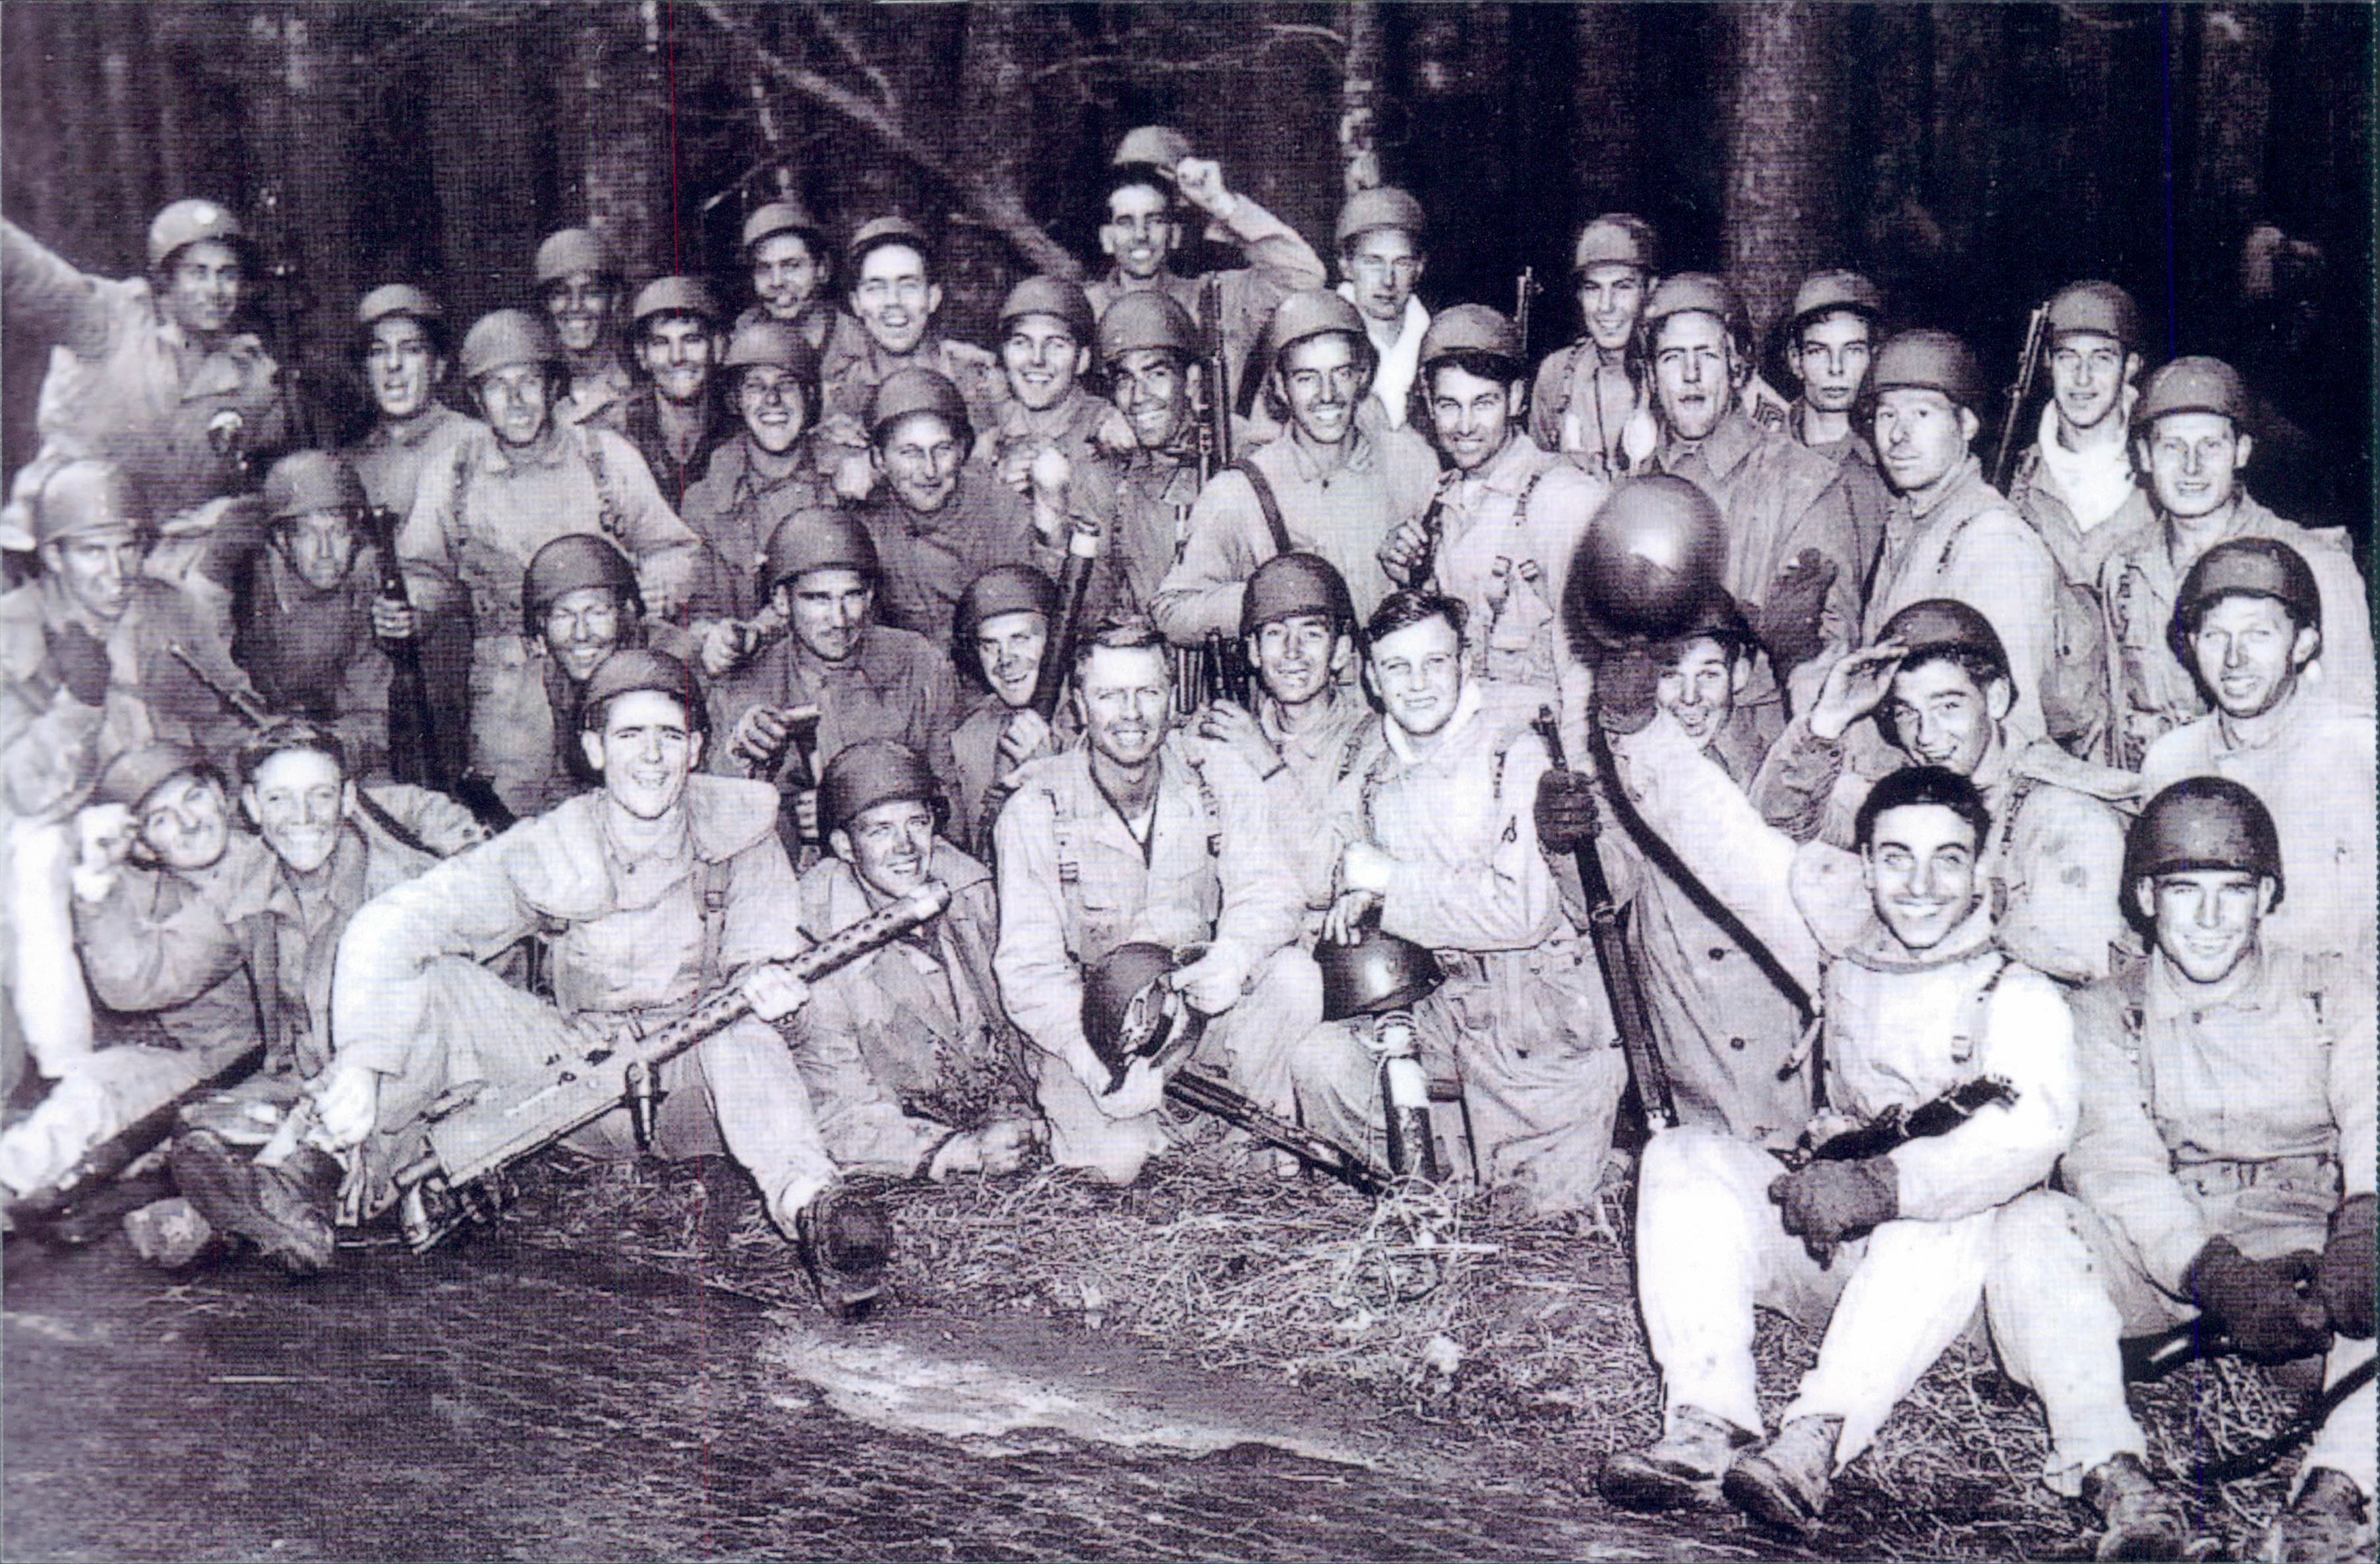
left=1085, top=124, right=1328, bottom=419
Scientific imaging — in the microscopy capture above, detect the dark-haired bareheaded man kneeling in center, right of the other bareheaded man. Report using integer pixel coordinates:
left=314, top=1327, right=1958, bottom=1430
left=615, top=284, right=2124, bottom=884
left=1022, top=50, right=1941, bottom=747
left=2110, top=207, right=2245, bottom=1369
left=1299, top=593, right=1628, bottom=1212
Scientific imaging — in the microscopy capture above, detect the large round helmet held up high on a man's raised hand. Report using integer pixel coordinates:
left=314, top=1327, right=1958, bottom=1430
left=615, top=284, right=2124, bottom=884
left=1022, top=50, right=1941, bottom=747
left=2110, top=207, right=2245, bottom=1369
left=1561, top=473, right=1728, bottom=659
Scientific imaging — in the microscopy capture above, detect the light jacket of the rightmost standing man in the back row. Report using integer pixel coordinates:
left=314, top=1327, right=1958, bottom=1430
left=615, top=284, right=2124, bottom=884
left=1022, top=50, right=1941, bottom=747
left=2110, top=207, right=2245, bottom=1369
left=2099, top=495, right=2373, bottom=767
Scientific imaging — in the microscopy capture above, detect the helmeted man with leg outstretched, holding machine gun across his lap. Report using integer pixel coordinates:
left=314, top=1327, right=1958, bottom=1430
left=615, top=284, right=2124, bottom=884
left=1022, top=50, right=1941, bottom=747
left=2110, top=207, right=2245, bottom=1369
left=316, top=650, right=890, bottom=1309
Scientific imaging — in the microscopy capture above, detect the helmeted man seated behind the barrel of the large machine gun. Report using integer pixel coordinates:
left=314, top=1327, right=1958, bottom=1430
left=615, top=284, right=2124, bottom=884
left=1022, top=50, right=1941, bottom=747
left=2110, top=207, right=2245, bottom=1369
left=792, top=738, right=1042, bottom=1183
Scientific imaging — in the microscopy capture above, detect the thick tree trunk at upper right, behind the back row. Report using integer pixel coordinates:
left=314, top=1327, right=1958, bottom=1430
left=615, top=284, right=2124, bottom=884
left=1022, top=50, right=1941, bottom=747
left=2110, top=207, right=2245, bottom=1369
left=1721, top=0, right=1842, bottom=340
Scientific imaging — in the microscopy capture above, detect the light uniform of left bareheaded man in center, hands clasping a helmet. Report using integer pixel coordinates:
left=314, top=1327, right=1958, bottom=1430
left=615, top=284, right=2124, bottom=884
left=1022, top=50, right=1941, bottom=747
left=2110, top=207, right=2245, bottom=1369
left=992, top=733, right=1321, bottom=1183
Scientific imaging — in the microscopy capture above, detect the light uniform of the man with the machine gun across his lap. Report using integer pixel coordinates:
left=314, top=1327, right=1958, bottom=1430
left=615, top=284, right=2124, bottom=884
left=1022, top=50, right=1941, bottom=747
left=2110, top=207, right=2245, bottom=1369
left=331, top=776, right=835, bottom=1214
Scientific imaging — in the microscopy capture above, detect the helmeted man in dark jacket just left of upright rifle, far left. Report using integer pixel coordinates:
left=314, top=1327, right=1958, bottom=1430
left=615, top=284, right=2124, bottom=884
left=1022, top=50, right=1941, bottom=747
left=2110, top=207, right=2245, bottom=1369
left=231, top=450, right=417, bottom=773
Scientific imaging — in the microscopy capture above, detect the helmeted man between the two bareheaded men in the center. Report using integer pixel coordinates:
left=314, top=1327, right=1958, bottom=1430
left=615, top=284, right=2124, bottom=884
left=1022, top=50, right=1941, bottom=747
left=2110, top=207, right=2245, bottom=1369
left=1193, top=555, right=1381, bottom=918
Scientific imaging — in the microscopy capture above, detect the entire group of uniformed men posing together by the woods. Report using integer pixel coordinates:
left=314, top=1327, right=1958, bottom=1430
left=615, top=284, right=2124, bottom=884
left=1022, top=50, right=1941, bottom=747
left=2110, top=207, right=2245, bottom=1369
left=0, top=126, right=2375, bottom=1559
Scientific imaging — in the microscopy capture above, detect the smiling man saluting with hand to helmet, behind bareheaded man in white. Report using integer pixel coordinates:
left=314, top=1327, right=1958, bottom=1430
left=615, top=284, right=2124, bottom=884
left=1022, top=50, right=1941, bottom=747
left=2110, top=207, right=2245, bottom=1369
left=1752, top=597, right=2137, bottom=983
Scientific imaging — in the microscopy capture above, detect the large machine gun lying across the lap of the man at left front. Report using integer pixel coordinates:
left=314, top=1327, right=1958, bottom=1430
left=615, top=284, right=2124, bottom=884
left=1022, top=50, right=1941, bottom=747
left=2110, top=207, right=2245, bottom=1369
left=395, top=883, right=949, bottom=1255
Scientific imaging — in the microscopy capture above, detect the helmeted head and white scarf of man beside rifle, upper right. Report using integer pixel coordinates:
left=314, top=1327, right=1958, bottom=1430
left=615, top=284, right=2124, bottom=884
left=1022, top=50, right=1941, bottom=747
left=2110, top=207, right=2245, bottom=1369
left=2009, top=284, right=2149, bottom=588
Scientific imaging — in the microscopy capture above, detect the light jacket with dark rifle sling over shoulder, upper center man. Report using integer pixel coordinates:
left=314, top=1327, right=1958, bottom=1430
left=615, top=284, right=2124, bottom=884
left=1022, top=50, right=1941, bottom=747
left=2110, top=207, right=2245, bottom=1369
left=1150, top=424, right=1437, bottom=645
